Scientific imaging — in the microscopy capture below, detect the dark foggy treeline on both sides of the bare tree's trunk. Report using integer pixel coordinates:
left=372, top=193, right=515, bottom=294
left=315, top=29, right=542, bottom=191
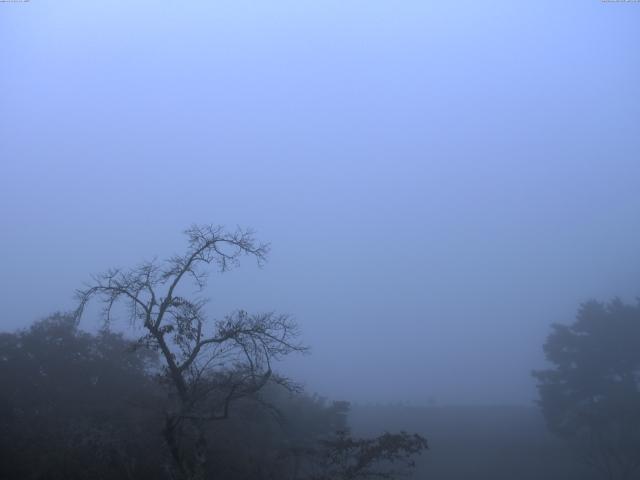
left=0, top=314, right=425, bottom=480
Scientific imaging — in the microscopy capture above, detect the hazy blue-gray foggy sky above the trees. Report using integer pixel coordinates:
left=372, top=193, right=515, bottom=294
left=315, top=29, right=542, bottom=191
left=0, top=0, right=640, bottom=403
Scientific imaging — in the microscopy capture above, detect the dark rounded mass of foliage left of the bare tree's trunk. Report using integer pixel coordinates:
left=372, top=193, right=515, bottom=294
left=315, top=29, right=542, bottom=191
left=0, top=314, right=166, bottom=479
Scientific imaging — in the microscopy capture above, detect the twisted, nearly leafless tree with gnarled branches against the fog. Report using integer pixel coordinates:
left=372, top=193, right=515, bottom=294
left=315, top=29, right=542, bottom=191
left=77, top=225, right=306, bottom=480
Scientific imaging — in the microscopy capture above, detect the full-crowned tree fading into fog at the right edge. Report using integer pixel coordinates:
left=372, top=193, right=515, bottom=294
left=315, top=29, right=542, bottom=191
left=533, top=299, right=640, bottom=479
